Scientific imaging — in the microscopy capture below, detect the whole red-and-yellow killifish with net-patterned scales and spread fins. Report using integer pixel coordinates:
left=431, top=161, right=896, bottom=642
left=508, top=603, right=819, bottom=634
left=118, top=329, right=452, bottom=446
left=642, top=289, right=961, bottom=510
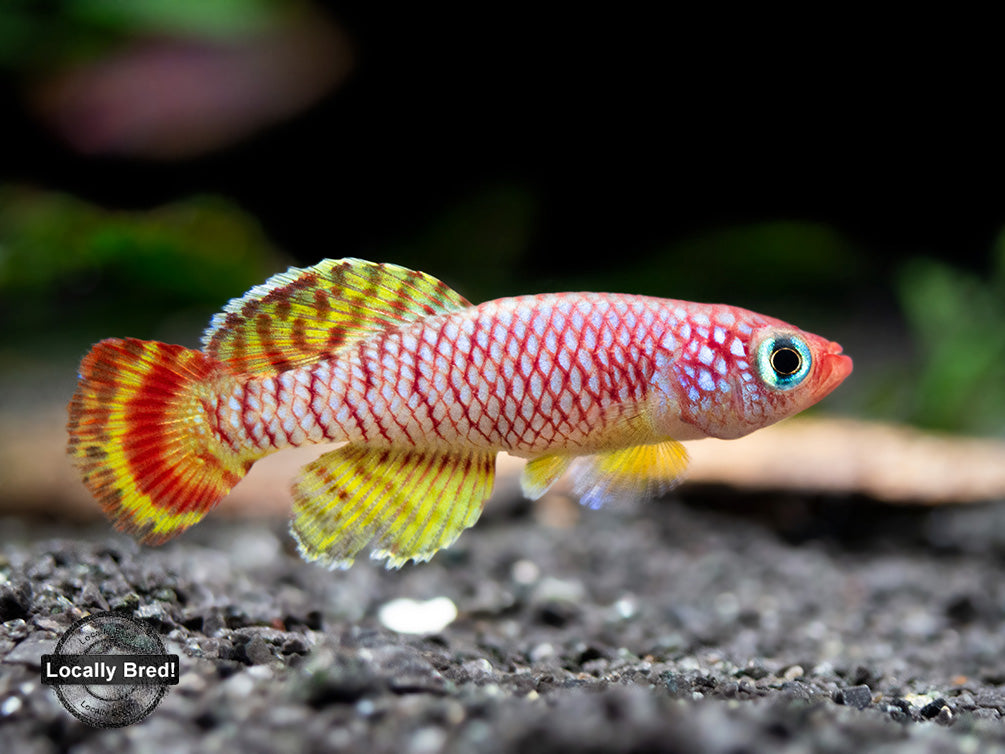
left=67, top=258, right=851, bottom=568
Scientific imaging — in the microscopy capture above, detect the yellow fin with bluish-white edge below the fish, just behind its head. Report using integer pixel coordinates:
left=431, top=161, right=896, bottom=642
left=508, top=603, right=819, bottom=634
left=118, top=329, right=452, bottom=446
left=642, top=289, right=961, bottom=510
left=572, top=439, right=687, bottom=508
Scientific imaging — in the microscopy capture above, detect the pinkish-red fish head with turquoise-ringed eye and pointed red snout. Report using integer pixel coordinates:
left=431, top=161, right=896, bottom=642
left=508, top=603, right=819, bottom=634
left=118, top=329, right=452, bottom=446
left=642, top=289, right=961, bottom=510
left=675, top=308, right=852, bottom=446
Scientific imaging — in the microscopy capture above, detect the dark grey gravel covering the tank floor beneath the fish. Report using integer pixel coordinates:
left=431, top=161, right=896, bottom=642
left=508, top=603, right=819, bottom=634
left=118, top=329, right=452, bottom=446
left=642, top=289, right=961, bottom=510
left=0, top=491, right=1005, bottom=754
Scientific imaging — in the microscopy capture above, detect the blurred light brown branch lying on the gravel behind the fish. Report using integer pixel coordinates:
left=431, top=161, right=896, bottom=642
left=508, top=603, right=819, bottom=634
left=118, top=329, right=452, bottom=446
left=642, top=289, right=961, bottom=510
left=0, top=408, right=1005, bottom=530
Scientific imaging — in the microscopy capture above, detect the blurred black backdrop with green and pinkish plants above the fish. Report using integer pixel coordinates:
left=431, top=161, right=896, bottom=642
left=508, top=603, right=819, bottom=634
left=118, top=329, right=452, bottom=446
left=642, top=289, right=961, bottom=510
left=0, top=0, right=1005, bottom=436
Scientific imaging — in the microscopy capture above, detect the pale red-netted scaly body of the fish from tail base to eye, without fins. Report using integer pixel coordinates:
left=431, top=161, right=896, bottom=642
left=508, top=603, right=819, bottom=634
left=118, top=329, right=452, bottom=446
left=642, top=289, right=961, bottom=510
left=220, top=294, right=852, bottom=455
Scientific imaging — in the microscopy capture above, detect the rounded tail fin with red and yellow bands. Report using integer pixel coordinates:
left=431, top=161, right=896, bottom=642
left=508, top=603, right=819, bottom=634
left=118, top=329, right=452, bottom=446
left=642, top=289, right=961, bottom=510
left=67, top=339, right=254, bottom=544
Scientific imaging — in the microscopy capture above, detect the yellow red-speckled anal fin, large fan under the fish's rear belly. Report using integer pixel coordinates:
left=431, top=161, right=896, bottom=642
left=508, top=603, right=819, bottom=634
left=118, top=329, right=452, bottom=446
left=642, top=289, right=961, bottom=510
left=291, top=444, right=495, bottom=568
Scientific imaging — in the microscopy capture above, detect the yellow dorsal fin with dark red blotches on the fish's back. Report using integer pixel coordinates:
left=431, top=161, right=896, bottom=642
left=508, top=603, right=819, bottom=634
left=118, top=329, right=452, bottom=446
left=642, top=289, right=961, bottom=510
left=202, top=258, right=471, bottom=375
